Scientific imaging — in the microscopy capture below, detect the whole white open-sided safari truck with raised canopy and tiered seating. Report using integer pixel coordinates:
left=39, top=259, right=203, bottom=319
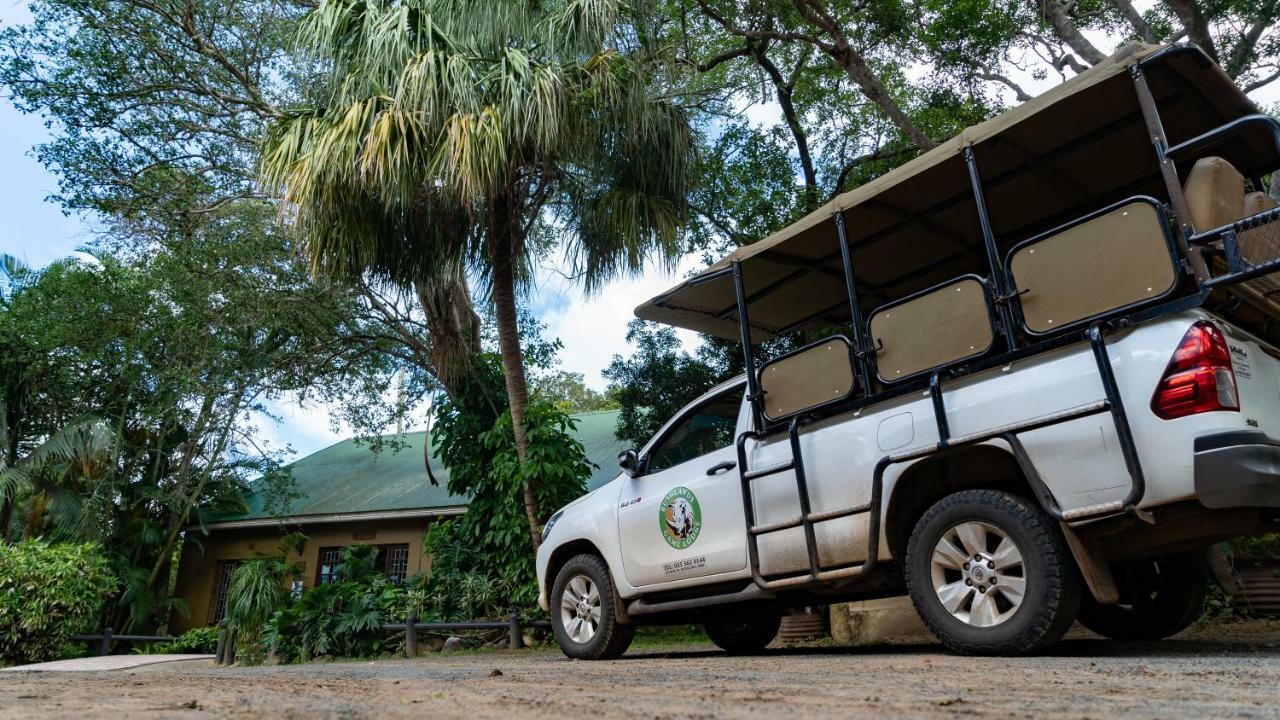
left=538, top=46, right=1280, bottom=659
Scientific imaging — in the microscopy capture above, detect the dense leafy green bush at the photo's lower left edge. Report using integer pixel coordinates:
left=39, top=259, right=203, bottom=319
left=0, top=541, right=115, bottom=662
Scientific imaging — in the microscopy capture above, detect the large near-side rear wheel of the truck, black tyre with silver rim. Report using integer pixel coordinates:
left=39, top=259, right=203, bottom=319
left=906, top=489, right=1080, bottom=655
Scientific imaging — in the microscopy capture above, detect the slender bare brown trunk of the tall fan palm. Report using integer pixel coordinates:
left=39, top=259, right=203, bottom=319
left=489, top=197, right=541, bottom=551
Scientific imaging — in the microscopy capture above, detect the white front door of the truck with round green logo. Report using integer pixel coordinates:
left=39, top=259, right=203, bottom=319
left=618, top=384, right=746, bottom=587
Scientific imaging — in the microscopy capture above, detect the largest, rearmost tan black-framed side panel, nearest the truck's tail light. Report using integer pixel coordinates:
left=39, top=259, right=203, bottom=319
left=1009, top=201, right=1178, bottom=333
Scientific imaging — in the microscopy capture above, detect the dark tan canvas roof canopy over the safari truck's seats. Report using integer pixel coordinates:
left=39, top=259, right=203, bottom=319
left=635, top=45, right=1280, bottom=342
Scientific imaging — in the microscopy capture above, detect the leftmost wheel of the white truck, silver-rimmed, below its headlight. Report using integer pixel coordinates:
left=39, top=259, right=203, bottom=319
left=550, top=555, right=635, bottom=660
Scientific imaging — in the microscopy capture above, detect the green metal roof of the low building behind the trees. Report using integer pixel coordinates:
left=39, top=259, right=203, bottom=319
left=207, top=410, right=627, bottom=523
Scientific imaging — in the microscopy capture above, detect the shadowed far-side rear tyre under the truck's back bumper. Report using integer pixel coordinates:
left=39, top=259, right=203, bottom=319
left=1080, top=552, right=1208, bottom=641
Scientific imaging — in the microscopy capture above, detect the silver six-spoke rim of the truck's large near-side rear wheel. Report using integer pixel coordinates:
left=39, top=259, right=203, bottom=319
left=931, top=520, right=1027, bottom=628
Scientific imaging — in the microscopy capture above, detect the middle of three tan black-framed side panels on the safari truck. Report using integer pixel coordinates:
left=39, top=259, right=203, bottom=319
left=869, top=278, right=995, bottom=383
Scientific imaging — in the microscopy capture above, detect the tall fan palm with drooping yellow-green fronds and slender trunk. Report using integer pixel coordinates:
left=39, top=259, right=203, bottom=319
left=261, top=0, right=694, bottom=547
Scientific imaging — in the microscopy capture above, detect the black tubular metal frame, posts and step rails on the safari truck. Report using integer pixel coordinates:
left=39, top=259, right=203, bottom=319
left=721, top=47, right=1280, bottom=589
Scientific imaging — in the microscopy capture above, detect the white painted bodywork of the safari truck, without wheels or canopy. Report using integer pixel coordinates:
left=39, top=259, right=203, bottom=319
left=538, top=304, right=1280, bottom=609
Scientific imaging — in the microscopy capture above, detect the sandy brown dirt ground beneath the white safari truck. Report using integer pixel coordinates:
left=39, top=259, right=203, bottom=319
left=0, top=621, right=1280, bottom=720
